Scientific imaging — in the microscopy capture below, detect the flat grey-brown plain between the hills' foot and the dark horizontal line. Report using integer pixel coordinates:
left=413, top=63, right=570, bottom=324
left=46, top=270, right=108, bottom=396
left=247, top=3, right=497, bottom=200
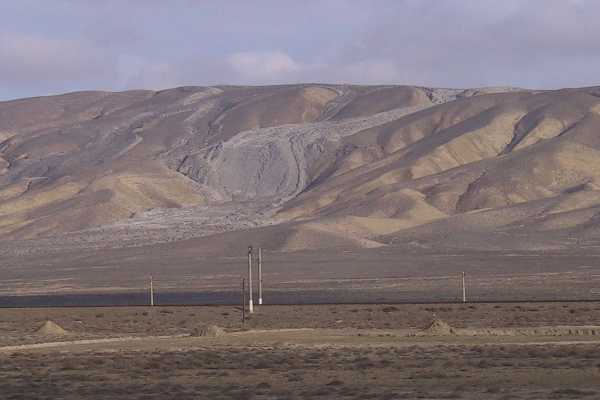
left=0, top=245, right=600, bottom=306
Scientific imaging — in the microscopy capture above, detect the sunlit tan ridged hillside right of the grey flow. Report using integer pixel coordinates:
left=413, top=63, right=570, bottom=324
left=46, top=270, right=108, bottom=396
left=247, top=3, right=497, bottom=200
left=280, top=89, right=600, bottom=250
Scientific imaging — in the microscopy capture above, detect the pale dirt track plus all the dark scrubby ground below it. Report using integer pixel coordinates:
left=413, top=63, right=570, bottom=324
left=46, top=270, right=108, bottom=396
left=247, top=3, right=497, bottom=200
left=0, top=329, right=600, bottom=399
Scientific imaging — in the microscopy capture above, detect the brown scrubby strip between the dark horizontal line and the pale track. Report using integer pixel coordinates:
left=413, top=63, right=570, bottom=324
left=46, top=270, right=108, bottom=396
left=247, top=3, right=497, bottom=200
left=0, top=302, right=600, bottom=345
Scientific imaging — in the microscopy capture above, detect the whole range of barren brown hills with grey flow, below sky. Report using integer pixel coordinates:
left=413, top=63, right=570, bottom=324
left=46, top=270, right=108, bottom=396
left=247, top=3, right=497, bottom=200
left=0, top=84, right=600, bottom=252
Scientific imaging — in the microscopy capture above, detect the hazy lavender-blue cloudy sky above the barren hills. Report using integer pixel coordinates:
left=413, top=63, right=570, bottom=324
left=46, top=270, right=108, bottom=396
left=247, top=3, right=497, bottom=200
left=0, top=0, right=600, bottom=100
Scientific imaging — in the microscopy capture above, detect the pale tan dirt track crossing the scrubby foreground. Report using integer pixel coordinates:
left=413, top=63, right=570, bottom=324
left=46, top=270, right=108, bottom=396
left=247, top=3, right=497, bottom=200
left=5, top=327, right=600, bottom=354
